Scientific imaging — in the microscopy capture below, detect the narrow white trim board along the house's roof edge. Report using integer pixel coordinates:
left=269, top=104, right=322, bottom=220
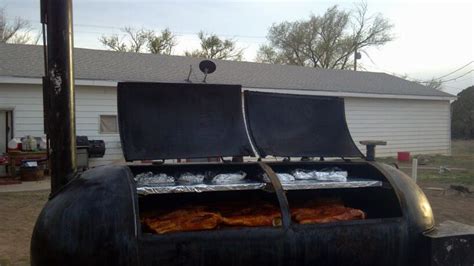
left=0, top=76, right=457, bottom=101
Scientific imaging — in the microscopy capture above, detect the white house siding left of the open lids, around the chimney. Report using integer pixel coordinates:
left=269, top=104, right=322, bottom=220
left=0, top=84, right=122, bottom=166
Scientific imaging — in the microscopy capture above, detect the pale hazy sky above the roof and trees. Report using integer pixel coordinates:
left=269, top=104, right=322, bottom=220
left=0, top=0, right=474, bottom=94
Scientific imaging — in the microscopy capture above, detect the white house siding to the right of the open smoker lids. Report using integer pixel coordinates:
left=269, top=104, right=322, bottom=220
left=345, top=98, right=451, bottom=156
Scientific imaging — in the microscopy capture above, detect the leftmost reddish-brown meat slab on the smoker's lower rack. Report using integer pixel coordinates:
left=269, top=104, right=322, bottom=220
left=143, top=207, right=221, bottom=234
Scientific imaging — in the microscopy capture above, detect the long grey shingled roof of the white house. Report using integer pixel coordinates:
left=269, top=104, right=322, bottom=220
left=0, top=44, right=453, bottom=98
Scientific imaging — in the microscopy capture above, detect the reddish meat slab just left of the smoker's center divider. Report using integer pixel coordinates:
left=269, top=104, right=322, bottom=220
left=221, top=203, right=281, bottom=226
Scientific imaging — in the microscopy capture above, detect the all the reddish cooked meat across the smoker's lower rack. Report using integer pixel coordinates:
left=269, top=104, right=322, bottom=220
left=142, top=199, right=365, bottom=234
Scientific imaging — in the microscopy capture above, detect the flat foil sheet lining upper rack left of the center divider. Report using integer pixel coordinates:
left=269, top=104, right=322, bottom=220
left=137, top=180, right=266, bottom=195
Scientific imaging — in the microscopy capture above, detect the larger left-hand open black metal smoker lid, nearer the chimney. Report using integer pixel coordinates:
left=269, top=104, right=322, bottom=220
left=117, top=82, right=254, bottom=161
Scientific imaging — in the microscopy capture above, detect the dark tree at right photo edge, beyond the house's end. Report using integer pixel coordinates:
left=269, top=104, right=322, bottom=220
left=451, top=86, right=474, bottom=139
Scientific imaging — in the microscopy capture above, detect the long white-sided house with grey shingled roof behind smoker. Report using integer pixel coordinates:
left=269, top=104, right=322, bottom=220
left=0, top=44, right=455, bottom=165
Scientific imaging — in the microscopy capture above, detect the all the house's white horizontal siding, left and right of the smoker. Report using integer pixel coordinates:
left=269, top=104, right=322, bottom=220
left=0, top=84, right=450, bottom=165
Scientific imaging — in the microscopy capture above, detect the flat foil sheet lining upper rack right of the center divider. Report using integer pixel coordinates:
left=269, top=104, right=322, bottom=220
left=282, top=179, right=382, bottom=190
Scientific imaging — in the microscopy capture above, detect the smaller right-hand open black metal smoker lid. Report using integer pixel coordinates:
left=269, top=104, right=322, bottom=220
left=244, top=91, right=363, bottom=157
